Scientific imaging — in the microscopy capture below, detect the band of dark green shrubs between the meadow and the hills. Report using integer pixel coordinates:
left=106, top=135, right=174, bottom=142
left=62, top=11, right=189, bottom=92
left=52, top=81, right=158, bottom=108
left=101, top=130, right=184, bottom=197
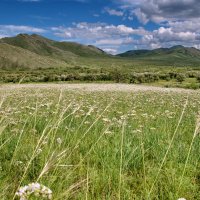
left=0, top=68, right=200, bottom=89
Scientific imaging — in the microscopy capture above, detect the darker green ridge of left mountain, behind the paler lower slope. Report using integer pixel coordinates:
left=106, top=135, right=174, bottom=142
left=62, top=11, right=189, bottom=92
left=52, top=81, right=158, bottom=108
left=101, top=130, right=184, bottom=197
left=0, top=34, right=107, bottom=61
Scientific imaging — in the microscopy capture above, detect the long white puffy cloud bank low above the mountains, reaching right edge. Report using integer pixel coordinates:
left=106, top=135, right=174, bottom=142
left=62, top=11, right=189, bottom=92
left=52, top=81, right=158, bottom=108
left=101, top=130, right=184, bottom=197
left=51, top=17, right=200, bottom=51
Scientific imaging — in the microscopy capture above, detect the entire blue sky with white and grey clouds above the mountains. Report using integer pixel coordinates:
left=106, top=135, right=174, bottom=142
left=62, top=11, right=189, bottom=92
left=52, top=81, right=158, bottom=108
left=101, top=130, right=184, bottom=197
left=0, top=0, right=200, bottom=54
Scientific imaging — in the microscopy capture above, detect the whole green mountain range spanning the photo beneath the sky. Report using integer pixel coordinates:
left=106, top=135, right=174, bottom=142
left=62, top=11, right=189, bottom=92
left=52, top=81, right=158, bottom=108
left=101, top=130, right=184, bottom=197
left=0, top=34, right=200, bottom=69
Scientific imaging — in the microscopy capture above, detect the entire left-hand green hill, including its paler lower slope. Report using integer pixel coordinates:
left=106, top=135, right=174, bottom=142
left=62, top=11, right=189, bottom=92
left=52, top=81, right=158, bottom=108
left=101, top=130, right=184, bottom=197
left=0, top=34, right=109, bottom=68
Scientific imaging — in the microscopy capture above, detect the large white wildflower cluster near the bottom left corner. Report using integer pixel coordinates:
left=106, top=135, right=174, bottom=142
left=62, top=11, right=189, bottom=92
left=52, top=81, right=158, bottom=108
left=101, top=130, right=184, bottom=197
left=16, top=183, right=52, bottom=200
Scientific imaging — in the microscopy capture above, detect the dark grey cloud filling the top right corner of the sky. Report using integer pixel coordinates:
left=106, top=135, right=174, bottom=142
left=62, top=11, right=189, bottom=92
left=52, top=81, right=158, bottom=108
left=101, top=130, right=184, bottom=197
left=120, top=0, right=200, bottom=23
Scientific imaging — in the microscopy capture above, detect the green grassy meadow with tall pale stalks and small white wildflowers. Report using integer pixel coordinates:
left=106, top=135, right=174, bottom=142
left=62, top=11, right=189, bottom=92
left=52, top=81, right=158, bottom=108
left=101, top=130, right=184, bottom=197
left=0, top=88, right=200, bottom=200
